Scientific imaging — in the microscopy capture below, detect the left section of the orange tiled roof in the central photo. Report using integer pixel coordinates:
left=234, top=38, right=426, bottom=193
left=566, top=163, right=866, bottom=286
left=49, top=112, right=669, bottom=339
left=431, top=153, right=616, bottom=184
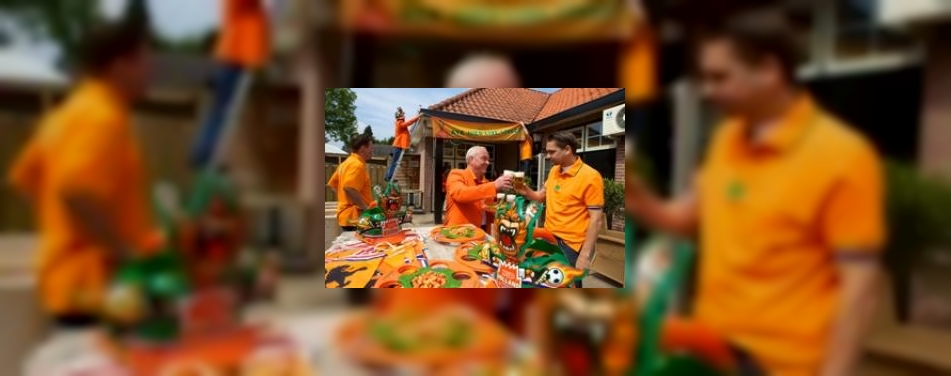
left=429, top=89, right=549, bottom=124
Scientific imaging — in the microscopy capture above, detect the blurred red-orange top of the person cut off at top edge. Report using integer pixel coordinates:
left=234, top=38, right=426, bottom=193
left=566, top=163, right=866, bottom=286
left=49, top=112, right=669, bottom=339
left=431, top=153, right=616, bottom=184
left=215, top=0, right=271, bottom=68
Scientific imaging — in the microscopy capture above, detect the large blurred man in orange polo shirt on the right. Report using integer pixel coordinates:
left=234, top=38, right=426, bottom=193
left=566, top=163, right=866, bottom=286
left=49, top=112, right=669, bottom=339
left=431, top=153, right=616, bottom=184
left=626, top=15, right=885, bottom=376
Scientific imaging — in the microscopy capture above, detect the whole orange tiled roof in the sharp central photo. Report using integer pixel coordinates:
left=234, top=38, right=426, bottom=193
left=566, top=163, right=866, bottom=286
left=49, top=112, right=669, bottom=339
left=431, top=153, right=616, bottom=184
left=429, top=88, right=623, bottom=124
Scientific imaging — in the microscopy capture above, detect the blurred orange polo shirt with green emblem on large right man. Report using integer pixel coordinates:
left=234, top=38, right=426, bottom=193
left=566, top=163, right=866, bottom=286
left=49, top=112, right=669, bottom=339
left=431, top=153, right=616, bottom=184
left=696, top=95, right=885, bottom=376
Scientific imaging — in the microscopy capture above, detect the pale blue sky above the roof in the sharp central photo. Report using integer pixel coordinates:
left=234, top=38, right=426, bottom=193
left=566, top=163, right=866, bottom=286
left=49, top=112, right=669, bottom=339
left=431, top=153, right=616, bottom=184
left=342, top=88, right=558, bottom=147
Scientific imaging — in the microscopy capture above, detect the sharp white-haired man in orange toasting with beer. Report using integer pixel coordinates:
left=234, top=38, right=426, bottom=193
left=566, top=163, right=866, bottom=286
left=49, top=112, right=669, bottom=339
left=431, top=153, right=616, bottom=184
left=445, top=146, right=512, bottom=230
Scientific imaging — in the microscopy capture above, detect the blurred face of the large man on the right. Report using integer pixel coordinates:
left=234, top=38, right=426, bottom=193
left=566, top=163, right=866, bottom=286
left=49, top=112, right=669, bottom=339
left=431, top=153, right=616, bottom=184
left=699, top=39, right=782, bottom=115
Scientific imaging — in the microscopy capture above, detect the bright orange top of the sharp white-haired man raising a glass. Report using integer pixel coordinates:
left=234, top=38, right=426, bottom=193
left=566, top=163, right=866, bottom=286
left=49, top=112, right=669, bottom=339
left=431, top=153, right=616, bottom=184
left=446, top=168, right=495, bottom=227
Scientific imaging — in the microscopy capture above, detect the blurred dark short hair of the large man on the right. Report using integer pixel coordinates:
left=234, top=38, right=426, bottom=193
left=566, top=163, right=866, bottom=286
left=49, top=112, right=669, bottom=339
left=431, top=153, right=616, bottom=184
left=698, top=10, right=802, bottom=83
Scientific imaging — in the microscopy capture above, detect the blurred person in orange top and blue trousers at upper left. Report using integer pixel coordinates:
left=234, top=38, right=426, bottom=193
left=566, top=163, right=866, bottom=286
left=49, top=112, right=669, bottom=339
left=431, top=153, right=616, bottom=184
left=191, top=0, right=271, bottom=167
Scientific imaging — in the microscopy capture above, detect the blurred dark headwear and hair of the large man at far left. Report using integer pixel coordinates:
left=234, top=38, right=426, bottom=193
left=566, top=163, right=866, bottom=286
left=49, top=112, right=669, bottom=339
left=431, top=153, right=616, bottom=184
left=79, top=18, right=151, bottom=74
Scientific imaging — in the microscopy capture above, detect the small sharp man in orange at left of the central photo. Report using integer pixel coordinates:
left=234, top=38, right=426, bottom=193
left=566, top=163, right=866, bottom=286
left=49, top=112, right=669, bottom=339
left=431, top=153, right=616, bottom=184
left=327, top=133, right=373, bottom=231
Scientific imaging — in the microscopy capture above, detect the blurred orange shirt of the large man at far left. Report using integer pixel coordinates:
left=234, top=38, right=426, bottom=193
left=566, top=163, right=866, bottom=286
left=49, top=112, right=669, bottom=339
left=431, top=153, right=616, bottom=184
left=9, top=81, right=159, bottom=314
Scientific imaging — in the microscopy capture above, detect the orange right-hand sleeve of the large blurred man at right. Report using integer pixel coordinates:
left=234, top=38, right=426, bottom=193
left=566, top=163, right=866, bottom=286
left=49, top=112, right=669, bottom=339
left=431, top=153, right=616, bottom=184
left=821, top=146, right=885, bottom=252
